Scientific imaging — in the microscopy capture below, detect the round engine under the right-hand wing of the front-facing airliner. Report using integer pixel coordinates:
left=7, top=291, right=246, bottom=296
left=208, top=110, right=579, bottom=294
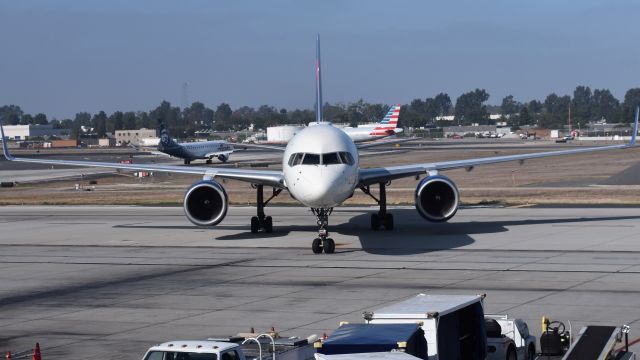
left=415, top=175, right=460, bottom=222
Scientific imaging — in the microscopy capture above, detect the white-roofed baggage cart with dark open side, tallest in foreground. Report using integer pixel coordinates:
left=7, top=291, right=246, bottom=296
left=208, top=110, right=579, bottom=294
left=363, top=294, right=487, bottom=360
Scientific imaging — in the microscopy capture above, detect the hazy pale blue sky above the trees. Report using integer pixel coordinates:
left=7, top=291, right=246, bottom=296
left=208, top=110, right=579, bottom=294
left=0, top=0, right=640, bottom=118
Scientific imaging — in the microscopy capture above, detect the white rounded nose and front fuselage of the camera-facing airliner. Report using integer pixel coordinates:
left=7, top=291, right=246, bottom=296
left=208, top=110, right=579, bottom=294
left=282, top=124, right=359, bottom=208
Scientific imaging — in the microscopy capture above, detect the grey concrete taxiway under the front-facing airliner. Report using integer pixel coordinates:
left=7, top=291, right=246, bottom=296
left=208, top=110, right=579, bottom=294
left=0, top=206, right=640, bottom=359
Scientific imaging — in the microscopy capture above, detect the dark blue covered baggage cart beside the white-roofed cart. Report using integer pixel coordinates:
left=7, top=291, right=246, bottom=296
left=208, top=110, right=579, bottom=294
left=318, top=324, right=428, bottom=359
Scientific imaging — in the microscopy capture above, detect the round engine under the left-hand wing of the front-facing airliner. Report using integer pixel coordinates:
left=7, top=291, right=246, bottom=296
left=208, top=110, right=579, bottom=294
left=184, top=180, right=229, bottom=226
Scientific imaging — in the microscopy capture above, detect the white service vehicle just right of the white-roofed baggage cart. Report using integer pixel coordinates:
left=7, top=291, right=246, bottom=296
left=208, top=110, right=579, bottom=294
left=484, top=314, right=536, bottom=360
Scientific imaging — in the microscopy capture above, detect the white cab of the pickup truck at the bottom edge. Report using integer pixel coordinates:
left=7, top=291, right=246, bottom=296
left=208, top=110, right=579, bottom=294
left=142, top=340, right=246, bottom=360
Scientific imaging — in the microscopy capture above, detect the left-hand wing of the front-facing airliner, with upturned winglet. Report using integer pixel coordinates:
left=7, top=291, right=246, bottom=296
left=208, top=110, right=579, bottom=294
left=0, top=122, right=285, bottom=188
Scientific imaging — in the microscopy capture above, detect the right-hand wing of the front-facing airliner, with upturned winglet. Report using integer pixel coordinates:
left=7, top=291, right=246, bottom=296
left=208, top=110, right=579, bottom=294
left=358, top=107, right=640, bottom=186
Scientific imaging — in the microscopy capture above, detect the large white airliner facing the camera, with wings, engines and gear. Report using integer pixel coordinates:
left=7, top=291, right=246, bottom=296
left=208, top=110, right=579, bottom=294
left=0, top=37, right=640, bottom=253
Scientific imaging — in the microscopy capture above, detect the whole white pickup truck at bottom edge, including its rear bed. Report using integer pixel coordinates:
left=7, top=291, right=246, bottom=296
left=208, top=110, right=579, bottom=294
left=142, top=340, right=315, bottom=360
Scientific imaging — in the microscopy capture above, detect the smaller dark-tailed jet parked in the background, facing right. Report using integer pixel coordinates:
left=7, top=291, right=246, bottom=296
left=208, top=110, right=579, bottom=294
left=158, top=124, right=234, bottom=165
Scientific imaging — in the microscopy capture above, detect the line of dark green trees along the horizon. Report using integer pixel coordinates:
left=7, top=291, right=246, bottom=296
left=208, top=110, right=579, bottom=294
left=0, top=86, right=640, bottom=138
